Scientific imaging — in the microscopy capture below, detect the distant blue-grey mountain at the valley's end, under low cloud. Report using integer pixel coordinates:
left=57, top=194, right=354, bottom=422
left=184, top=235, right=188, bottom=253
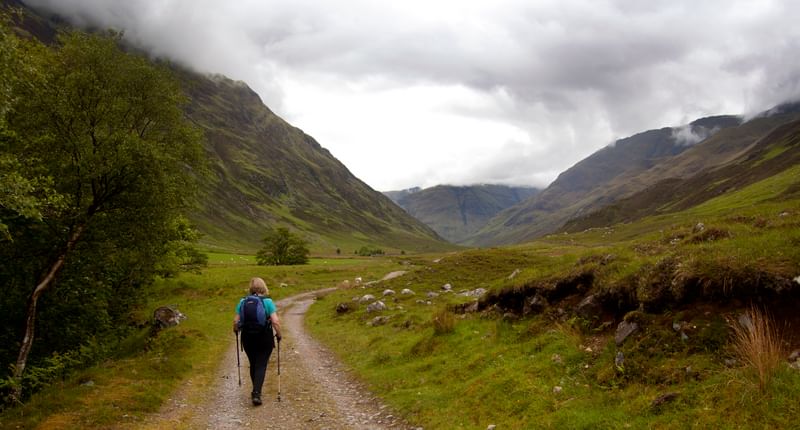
left=384, top=185, right=539, bottom=243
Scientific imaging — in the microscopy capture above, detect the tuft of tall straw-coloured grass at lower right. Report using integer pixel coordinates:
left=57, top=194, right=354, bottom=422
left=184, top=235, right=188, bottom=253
left=730, top=307, right=786, bottom=392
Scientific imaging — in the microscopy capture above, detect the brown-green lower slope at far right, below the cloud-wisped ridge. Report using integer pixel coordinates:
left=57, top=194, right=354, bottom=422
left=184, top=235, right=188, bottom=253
left=563, top=117, right=800, bottom=232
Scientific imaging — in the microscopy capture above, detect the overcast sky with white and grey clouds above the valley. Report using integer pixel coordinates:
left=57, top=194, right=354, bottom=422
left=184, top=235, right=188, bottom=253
left=26, top=0, right=800, bottom=191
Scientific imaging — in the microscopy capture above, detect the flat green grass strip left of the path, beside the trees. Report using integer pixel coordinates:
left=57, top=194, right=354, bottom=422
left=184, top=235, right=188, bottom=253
left=0, top=253, right=401, bottom=429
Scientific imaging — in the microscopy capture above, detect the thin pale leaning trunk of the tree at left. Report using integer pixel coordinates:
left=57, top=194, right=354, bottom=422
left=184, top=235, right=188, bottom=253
left=11, top=225, right=85, bottom=401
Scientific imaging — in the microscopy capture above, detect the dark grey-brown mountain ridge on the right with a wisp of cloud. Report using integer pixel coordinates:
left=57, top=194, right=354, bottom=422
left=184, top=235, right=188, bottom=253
left=465, top=109, right=799, bottom=246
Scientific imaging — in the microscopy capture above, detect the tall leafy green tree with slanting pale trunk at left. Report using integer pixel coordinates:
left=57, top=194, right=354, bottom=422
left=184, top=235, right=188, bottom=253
left=0, top=32, right=203, bottom=398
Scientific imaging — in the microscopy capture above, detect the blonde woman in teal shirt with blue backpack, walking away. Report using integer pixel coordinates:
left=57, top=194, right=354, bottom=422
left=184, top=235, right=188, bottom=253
left=233, top=278, right=281, bottom=406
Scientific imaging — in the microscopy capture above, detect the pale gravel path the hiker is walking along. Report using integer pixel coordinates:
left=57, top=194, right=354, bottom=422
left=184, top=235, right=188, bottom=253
left=146, top=292, right=413, bottom=430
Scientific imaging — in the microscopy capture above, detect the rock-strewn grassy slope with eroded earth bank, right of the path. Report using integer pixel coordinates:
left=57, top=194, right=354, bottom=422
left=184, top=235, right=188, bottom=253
left=308, top=169, right=800, bottom=429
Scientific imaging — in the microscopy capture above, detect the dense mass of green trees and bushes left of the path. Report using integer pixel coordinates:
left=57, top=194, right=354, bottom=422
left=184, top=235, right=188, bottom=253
left=0, top=24, right=203, bottom=400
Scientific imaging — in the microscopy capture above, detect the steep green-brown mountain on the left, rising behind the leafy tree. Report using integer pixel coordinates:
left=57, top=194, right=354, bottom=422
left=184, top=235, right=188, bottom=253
left=9, top=0, right=450, bottom=253
